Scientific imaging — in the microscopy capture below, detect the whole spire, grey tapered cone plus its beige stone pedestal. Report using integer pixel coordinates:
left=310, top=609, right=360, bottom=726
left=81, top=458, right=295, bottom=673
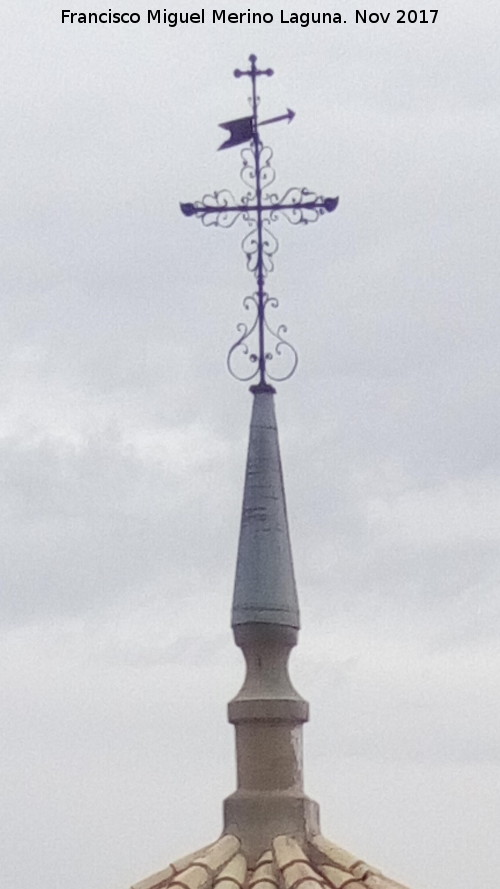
left=224, top=385, right=319, bottom=862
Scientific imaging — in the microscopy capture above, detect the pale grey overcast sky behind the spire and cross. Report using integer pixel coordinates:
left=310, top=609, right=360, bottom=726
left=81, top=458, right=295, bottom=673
left=0, top=0, right=500, bottom=889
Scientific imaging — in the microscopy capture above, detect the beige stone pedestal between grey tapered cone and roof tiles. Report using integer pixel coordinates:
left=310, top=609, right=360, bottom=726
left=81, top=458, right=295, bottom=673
left=224, top=624, right=319, bottom=862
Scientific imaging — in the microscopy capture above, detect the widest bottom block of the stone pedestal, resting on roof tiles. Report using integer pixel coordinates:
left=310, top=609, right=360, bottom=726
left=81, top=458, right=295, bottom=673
left=224, top=790, right=320, bottom=868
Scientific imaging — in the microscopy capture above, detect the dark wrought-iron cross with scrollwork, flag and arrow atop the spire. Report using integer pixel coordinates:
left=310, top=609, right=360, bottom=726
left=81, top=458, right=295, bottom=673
left=181, top=55, right=339, bottom=390
